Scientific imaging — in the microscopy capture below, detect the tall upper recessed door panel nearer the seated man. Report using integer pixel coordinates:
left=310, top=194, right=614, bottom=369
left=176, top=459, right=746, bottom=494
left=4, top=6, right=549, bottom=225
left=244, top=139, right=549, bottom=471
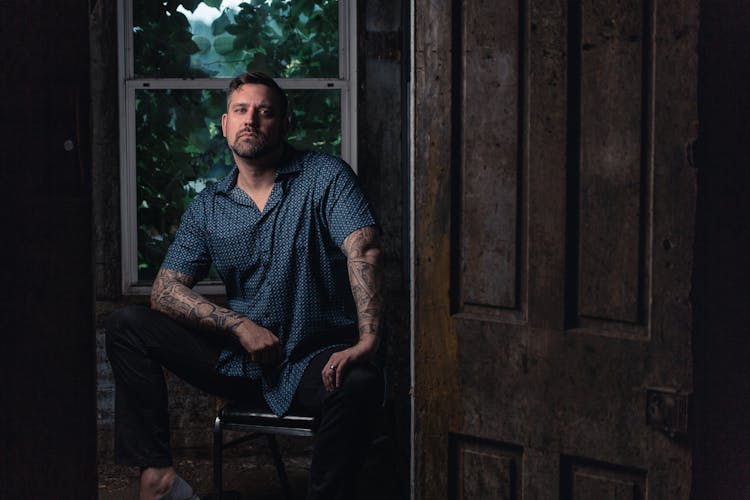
left=454, top=0, right=522, bottom=312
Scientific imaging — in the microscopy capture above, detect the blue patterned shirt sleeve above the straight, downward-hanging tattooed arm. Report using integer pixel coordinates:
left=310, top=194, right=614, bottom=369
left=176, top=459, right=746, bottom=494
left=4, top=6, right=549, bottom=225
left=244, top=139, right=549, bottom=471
left=322, top=157, right=376, bottom=247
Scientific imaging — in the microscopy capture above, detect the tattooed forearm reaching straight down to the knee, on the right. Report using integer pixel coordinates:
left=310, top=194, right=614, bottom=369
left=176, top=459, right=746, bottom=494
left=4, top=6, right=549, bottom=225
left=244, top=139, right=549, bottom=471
left=342, top=226, right=383, bottom=348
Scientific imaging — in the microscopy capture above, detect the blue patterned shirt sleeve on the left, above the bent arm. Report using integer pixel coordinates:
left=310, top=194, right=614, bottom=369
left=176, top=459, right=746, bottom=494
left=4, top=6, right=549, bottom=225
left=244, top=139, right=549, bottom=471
left=161, top=196, right=211, bottom=281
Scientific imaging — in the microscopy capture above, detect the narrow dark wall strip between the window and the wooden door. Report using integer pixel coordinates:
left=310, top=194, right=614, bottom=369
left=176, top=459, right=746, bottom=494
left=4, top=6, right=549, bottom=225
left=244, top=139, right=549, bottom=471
left=357, top=0, right=411, bottom=490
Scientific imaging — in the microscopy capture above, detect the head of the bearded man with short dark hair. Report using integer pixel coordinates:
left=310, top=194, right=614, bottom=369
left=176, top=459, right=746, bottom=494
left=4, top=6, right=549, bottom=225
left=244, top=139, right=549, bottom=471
left=221, top=83, right=287, bottom=160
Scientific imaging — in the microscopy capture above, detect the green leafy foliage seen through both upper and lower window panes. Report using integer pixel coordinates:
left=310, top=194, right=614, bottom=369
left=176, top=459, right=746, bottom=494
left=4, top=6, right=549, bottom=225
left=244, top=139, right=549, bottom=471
left=133, top=0, right=341, bottom=280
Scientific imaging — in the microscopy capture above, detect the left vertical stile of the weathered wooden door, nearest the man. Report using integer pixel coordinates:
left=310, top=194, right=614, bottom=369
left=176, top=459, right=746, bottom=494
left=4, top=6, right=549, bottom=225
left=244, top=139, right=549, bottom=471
left=413, top=1, right=461, bottom=500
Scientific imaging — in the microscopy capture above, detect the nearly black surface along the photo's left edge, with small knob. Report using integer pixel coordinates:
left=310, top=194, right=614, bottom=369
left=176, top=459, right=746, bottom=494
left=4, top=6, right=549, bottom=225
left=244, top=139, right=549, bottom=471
left=0, top=0, right=97, bottom=499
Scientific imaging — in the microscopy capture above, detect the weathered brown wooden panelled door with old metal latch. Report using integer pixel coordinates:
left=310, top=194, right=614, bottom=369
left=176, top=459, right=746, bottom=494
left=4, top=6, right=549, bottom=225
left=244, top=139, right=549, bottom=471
left=413, top=0, right=697, bottom=500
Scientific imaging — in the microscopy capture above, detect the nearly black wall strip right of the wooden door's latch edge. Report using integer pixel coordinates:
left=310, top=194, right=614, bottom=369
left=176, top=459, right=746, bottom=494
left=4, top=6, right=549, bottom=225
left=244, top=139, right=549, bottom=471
left=693, top=0, right=750, bottom=500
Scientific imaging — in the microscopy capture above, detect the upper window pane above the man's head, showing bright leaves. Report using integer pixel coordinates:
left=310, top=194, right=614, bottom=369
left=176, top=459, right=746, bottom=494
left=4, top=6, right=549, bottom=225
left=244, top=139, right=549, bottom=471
left=133, top=0, right=339, bottom=78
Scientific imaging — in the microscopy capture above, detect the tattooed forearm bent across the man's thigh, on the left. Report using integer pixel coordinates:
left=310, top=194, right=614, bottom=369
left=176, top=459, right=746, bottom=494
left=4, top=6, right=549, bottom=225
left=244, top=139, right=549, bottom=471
left=151, top=269, right=247, bottom=332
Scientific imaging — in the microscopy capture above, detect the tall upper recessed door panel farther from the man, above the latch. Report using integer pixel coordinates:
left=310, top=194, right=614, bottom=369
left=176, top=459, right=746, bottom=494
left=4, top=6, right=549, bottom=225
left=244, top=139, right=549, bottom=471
left=580, top=0, right=653, bottom=328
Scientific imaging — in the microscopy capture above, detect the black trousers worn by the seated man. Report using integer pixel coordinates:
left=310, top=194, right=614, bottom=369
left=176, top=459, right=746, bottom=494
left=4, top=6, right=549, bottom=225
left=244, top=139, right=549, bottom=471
left=106, top=306, right=383, bottom=499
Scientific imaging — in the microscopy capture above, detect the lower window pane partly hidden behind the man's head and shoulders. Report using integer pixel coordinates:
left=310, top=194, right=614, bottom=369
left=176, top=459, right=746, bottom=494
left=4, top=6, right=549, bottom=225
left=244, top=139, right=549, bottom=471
left=135, top=89, right=341, bottom=281
